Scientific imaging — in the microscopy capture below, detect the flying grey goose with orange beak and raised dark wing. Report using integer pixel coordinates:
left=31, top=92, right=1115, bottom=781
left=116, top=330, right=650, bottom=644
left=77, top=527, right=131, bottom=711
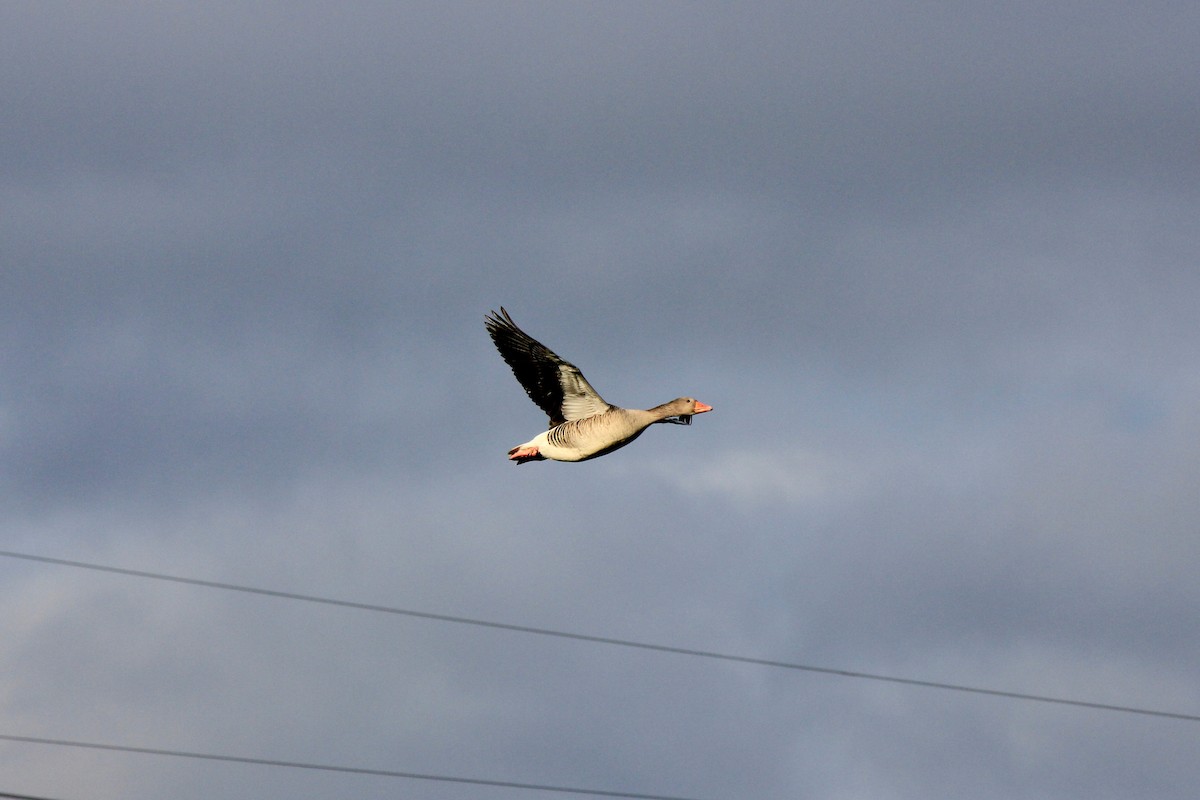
left=484, top=306, right=713, bottom=464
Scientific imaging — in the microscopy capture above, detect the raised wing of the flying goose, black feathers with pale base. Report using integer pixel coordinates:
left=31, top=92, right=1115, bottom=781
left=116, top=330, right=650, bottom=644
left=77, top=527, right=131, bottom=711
left=484, top=306, right=612, bottom=427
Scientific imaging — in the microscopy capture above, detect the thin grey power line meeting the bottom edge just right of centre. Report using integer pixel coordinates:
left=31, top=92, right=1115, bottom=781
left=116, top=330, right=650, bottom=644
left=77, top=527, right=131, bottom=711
left=0, top=733, right=696, bottom=800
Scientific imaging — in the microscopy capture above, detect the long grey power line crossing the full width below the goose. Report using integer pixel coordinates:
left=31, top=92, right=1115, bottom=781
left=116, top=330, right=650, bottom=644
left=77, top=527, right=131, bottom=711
left=0, top=551, right=1200, bottom=722
